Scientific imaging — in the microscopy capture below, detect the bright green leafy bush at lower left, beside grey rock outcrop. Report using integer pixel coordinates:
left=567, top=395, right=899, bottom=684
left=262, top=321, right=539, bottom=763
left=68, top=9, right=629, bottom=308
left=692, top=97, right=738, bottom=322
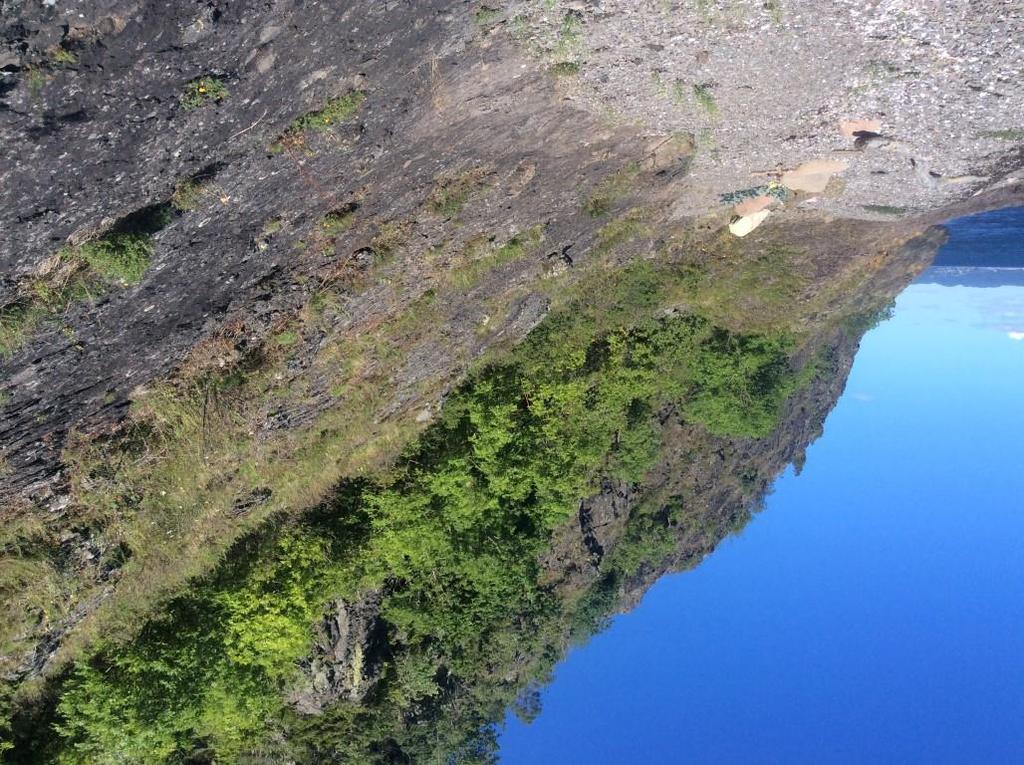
left=56, top=532, right=332, bottom=763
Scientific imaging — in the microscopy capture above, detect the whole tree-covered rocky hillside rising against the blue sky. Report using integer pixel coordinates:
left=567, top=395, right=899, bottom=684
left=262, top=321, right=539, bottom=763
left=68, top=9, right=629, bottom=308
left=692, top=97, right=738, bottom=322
left=6, top=224, right=937, bottom=762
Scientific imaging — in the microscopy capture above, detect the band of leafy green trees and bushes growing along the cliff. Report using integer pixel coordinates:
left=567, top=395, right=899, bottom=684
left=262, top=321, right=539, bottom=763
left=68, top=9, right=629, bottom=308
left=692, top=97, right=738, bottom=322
left=37, top=276, right=802, bottom=763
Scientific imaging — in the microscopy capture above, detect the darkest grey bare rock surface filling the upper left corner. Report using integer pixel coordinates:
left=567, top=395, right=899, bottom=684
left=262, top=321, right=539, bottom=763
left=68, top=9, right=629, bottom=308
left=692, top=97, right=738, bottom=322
left=0, top=2, right=460, bottom=497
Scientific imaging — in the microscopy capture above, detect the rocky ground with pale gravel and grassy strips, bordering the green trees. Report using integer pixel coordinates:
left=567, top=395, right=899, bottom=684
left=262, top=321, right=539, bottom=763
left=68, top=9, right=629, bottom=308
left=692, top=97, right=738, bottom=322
left=0, top=0, right=1024, bottom=761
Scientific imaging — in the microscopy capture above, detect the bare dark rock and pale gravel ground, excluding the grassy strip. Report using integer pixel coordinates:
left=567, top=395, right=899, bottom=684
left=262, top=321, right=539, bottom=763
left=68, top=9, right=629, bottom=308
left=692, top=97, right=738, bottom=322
left=0, top=2, right=1024, bottom=505
